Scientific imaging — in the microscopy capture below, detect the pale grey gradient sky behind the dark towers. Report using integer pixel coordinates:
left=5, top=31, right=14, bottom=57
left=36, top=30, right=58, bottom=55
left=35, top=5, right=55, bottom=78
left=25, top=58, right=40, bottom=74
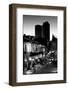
left=23, top=15, right=57, bottom=40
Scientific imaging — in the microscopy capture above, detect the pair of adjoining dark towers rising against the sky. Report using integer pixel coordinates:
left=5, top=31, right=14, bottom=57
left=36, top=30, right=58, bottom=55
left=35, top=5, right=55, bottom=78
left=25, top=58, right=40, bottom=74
left=35, top=22, right=50, bottom=43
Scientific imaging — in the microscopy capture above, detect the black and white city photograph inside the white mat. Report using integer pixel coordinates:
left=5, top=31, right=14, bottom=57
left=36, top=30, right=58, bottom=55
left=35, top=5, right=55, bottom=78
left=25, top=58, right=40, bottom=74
left=23, top=15, right=58, bottom=75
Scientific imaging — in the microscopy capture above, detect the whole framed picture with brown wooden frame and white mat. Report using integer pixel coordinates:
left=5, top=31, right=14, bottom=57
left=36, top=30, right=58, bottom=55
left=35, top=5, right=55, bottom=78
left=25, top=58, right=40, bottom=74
left=9, top=4, right=66, bottom=86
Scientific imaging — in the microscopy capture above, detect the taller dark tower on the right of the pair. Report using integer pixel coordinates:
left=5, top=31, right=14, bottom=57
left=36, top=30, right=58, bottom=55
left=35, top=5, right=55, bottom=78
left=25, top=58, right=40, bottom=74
left=42, top=22, right=50, bottom=41
